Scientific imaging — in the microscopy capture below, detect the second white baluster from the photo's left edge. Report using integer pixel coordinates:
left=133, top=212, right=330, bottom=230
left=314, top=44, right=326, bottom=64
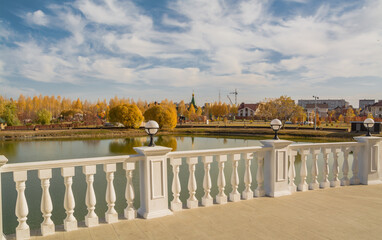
left=38, top=169, right=55, bottom=236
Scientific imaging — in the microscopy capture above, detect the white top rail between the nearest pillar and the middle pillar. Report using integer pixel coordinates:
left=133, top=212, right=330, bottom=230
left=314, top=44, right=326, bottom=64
left=167, top=146, right=271, bottom=158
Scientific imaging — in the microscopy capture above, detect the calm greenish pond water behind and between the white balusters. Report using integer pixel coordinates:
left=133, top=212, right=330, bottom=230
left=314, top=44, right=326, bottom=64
left=0, top=136, right=352, bottom=235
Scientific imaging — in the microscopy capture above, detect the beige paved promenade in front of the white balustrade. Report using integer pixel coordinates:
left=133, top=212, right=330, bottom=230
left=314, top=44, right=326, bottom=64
left=8, top=185, right=382, bottom=240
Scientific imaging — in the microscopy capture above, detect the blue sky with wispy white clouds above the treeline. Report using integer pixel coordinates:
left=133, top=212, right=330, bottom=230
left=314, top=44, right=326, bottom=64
left=0, top=0, right=382, bottom=106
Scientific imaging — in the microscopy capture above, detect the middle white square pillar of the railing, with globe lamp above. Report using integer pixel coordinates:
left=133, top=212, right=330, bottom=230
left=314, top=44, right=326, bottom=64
left=260, top=140, right=292, bottom=197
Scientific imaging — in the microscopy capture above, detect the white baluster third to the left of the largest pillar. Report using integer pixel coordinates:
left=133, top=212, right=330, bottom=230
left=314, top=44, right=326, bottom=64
left=82, top=165, right=98, bottom=227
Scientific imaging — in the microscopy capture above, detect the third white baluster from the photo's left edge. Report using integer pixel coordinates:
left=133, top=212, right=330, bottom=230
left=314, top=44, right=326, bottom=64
left=61, top=167, right=78, bottom=232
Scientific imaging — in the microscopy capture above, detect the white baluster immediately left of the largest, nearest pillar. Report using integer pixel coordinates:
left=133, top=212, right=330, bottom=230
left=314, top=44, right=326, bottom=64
left=123, top=162, right=137, bottom=220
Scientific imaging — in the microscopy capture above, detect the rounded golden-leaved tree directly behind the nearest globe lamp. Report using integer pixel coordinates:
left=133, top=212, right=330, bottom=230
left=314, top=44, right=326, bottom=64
left=144, top=105, right=177, bottom=129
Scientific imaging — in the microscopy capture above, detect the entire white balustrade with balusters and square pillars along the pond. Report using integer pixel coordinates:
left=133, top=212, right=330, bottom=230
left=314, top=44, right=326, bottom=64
left=0, top=137, right=382, bottom=239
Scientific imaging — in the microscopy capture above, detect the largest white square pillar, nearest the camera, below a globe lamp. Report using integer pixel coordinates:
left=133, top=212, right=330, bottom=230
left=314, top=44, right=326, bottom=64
left=134, top=146, right=173, bottom=219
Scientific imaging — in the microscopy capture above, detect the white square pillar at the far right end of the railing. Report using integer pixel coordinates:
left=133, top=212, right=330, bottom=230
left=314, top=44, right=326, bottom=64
left=354, top=136, right=382, bottom=185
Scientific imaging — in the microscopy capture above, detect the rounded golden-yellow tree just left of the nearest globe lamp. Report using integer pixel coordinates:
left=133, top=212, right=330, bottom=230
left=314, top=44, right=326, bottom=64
left=109, top=104, right=143, bottom=128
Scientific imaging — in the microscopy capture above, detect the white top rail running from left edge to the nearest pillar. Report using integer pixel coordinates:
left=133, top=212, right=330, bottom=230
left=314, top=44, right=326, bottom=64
left=0, top=154, right=142, bottom=173
